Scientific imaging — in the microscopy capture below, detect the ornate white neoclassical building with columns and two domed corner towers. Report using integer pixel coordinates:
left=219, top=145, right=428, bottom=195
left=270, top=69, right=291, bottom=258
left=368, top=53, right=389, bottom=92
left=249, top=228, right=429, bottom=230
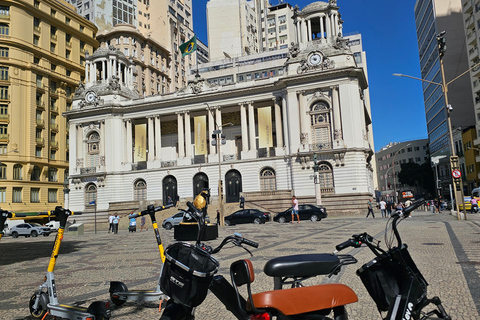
left=65, top=0, right=374, bottom=214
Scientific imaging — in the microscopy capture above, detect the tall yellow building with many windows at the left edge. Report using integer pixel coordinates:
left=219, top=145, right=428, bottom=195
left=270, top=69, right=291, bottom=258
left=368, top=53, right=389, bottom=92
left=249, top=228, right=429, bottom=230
left=0, top=0, right=98, bottom=212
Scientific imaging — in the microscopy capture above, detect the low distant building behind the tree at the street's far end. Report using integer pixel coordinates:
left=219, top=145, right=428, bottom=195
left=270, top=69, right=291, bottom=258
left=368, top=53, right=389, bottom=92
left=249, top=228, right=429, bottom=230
left=375, top=139, right=430, bottom=201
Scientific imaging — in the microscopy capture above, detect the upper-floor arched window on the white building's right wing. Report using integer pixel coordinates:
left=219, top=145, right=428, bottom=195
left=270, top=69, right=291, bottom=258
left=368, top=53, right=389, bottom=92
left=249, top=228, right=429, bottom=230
left=310, top=101, right=332, bottom=150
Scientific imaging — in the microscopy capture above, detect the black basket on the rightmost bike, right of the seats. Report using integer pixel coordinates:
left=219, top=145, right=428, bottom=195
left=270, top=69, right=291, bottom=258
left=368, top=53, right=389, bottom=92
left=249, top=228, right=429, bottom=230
left=357, top=245, right=428, bottom=311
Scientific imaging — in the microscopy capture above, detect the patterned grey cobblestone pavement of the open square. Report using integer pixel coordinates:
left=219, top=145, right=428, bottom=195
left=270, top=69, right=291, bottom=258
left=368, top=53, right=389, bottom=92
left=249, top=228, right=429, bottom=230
left=0, top=211, right=480, bottom=320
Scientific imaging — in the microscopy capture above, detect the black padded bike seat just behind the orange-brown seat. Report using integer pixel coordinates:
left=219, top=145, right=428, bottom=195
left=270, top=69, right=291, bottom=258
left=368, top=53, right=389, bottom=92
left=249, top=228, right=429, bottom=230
left=263, top=253, right=340, bottom=277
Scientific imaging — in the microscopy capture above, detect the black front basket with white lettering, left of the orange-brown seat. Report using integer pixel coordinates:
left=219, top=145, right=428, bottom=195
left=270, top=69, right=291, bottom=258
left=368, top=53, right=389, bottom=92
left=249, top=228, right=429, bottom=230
left=160, top=242, right=219, bottom=307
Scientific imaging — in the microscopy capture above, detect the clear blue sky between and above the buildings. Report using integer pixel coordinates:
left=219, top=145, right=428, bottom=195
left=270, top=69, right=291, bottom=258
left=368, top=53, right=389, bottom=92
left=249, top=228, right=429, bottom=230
left=192, top=0, right=427, bottom=151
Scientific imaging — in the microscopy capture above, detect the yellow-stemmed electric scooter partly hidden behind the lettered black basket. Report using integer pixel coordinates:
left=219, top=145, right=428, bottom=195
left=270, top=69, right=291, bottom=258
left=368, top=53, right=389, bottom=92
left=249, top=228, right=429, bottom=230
left=109, top=204, right=173, bottom=306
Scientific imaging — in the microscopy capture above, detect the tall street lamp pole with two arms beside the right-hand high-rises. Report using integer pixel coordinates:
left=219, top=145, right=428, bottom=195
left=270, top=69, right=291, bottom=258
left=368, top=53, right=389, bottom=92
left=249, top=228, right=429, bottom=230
left=393, top=31, right=480, bottom=220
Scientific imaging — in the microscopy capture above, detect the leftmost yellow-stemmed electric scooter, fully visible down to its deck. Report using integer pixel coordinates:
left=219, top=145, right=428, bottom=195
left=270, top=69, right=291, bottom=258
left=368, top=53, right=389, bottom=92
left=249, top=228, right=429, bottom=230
left=29, top=206, right=111, bottom=320
